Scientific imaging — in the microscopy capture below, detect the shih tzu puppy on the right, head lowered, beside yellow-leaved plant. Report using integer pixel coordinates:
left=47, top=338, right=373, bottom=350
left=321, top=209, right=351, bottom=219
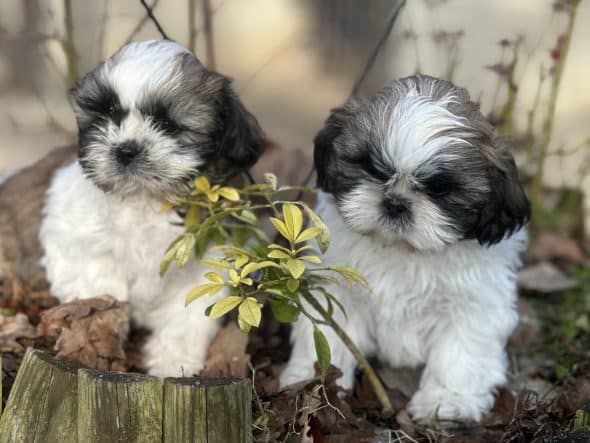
left=281, top=76, right=530, bottom=422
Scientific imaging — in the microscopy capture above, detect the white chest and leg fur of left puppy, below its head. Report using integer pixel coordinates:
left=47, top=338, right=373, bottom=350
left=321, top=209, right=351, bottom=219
left=40, top=161, right=219, bottom=376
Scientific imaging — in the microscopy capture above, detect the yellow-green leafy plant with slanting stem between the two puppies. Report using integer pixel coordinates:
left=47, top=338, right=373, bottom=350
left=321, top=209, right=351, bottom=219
left=160, top=174, right=392, bottom=412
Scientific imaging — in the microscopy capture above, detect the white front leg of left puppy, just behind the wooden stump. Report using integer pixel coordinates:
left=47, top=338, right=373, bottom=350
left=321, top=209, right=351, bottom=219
left=143, top=282, right=219, bottom=377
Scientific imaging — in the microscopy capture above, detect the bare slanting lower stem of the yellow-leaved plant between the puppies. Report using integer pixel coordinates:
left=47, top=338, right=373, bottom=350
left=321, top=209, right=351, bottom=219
left=301, top=291, right=394, bottom=414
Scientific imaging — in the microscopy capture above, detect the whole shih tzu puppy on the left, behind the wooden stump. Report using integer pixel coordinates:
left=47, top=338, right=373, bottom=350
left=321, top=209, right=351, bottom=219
left=40, top=41, right=262, bottom=376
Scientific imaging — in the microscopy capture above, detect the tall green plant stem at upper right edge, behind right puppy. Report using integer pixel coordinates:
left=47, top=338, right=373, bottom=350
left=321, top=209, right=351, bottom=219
left=530, top=0, right=581, bottom=202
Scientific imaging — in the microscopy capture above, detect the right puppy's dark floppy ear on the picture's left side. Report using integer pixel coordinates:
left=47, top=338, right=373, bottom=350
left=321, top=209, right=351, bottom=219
left=313, top=99, right=360, bottom=192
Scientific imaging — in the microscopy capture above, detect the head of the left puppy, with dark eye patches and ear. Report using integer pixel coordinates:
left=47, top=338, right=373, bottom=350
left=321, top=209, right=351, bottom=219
left=70, top=41, right=262, bottom=198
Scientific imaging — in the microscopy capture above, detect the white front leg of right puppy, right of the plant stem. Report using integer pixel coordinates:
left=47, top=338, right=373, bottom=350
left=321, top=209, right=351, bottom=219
left=408, top=306, right=517, bottom=422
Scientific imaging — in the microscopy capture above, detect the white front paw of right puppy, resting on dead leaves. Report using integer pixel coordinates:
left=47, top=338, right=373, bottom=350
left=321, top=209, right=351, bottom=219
left=407, top=384, right=494, bottom=424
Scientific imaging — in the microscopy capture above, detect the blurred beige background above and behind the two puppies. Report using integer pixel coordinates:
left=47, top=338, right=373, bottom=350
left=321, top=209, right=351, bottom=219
left=0, top=0, right=590, bottom=239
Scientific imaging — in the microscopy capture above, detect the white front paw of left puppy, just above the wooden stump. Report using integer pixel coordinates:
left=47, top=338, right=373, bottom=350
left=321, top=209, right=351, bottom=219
left=144, top=340, right=206, bottom=378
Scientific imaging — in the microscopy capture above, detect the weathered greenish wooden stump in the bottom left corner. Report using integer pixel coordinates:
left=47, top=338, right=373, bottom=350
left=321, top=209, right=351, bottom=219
left=0, top=348, right=252, bottom=443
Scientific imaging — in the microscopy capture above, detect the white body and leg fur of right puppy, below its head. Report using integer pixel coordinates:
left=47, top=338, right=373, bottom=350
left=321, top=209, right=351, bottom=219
left=280, top=193, right=526, bottom=421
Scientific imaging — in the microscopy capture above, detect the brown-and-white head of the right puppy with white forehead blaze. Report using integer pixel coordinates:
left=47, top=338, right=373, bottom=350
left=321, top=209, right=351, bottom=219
left=314, top=76, right=530, bottom=250
